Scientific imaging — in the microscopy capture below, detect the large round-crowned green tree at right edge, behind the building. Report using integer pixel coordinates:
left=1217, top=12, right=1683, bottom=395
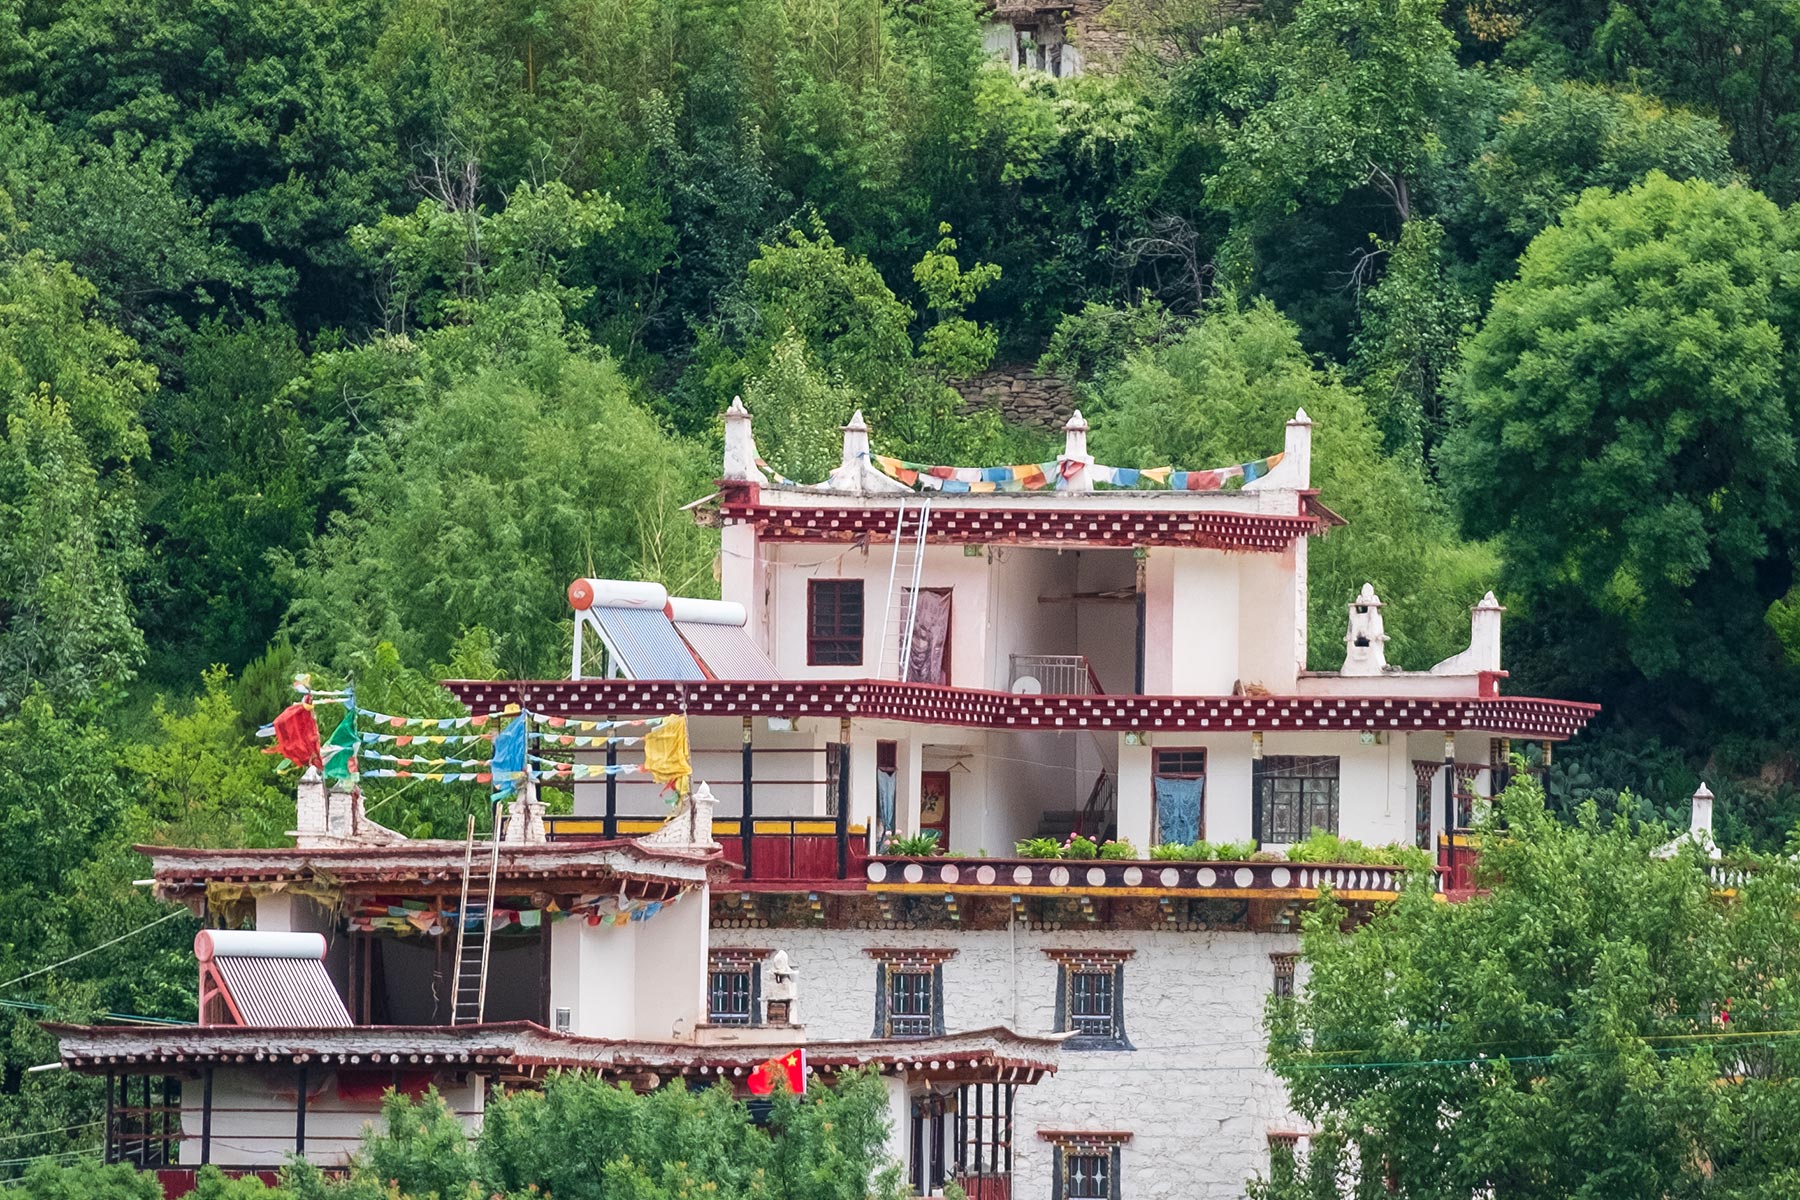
left=1442, top=175, right=1800, bottom=723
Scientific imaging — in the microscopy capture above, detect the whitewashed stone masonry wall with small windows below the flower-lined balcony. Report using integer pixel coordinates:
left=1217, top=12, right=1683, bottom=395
left=713, top=927, right=1298, bottom=1200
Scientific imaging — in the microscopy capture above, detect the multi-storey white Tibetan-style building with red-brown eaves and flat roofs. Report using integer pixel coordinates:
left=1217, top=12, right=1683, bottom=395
left=59, top=405, right=1593, bottom=1200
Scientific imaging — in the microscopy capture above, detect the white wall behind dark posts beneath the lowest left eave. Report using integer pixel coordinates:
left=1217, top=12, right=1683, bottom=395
left=180, top=1063, right=486, bottom=1166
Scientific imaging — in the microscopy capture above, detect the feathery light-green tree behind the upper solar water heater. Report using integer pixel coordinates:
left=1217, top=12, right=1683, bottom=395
left=288, top=353, right=715, bottom=678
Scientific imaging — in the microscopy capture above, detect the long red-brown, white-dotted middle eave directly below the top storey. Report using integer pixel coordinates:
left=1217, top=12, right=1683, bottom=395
left=445, top=680, right=1600, bottom=741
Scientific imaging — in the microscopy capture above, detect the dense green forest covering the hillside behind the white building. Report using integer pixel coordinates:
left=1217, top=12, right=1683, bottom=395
left=0, top=0, right=1800, bottom=1178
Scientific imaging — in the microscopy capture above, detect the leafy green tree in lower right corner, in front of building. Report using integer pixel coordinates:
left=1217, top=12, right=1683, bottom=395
left=1255, top=775, right=1800, bottom=1200
